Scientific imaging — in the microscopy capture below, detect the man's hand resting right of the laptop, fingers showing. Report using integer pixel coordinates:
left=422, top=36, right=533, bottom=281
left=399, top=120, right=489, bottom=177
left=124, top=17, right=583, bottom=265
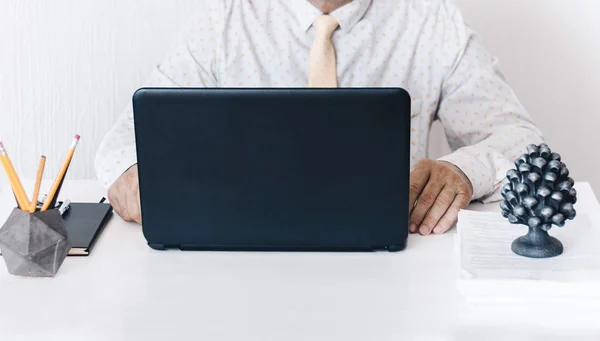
left=409, top=159, right=473, bottom=235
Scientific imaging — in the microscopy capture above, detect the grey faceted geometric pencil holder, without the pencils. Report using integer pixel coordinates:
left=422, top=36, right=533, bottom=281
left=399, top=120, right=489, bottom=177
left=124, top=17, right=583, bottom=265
left=0, top=208, right=71, bottom=277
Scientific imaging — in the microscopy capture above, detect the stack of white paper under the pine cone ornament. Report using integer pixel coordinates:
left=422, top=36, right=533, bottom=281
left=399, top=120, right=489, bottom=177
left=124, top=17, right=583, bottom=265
left=456, top=185, right=600, bottom=327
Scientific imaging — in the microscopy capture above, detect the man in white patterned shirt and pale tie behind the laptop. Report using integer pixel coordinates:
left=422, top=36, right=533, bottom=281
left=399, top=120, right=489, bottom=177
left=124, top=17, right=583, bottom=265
left=96, top=0, right=542, bottom=235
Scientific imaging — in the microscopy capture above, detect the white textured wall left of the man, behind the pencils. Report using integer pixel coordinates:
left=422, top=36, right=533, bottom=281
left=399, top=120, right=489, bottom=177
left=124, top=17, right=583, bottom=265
left=0, top=0, right=204, bottom=194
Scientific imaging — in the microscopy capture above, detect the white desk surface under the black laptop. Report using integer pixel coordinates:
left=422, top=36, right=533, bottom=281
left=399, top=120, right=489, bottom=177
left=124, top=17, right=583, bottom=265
left=0, top=181, right=600, bottom=341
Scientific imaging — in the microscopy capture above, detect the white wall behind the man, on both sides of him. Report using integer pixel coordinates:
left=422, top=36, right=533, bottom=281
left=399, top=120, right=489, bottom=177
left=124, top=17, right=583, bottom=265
left=0, top=0, right=600, bottom=193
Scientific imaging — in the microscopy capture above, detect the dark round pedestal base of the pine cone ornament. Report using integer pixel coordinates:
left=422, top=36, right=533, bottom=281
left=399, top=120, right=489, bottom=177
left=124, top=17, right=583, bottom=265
left=511, top=227, right=563, bottom=258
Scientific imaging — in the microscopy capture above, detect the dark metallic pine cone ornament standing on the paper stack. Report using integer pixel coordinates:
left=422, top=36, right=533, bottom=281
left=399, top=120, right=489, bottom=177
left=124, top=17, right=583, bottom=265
left=500, top=144, right=577, bottom=258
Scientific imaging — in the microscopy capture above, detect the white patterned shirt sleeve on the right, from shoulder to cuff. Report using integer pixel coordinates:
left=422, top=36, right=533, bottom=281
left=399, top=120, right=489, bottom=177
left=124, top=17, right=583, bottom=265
left=437, top=1, right=543, bottom=202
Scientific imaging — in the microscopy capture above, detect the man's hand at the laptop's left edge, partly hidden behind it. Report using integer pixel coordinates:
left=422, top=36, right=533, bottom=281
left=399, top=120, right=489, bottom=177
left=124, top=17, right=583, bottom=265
left=108, top=165, right=142, bottom=224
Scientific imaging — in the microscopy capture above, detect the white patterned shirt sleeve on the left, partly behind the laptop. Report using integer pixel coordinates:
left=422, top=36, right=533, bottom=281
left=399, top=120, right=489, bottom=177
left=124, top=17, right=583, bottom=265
left=94, top=1, right=219, bottom=188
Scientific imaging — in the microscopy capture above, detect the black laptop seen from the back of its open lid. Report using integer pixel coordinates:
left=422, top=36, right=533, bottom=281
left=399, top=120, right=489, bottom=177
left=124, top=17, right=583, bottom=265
left=133, top=88, right=411, bottom=251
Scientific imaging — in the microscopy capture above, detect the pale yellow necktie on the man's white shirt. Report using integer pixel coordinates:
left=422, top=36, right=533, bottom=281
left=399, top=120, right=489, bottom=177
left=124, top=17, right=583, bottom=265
left=310, top=15, right=339, bottom=88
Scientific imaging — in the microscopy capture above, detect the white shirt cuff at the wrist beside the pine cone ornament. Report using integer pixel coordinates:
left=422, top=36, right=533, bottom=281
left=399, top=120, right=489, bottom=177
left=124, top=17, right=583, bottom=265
left=438, top=147, right=511, bottom=202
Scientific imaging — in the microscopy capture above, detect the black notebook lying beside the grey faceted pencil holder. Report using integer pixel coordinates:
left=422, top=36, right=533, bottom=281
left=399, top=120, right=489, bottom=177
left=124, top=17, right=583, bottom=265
left=63, top=203, right=112, bottom=256
